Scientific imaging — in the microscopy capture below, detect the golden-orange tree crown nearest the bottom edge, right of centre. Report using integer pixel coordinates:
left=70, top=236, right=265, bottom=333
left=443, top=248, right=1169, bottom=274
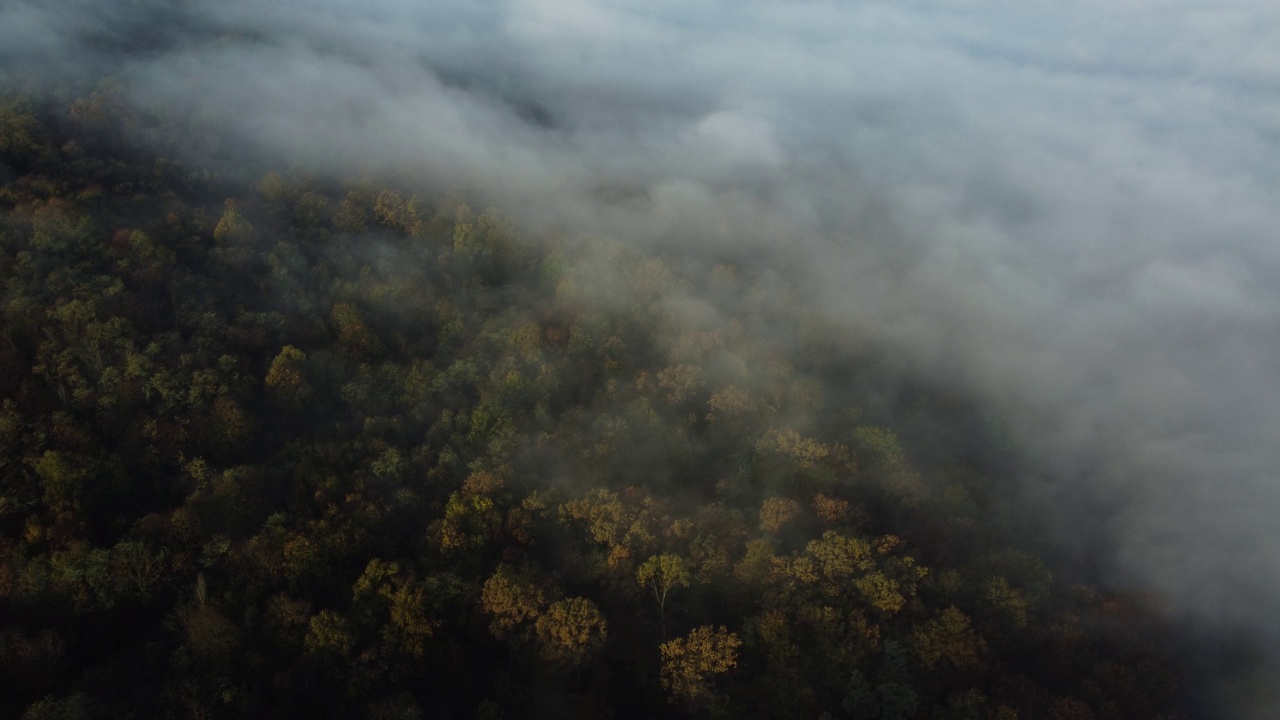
left=659, top=625, right=742, bottom=708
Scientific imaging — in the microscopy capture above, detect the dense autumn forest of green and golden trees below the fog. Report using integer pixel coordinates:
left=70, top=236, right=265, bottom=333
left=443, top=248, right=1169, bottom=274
left=0, top=90, right=1183, bottom=720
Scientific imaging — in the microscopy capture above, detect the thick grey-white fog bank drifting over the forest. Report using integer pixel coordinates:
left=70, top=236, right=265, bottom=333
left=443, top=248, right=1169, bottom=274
left=0, top=0, right=1280, bottom=717
